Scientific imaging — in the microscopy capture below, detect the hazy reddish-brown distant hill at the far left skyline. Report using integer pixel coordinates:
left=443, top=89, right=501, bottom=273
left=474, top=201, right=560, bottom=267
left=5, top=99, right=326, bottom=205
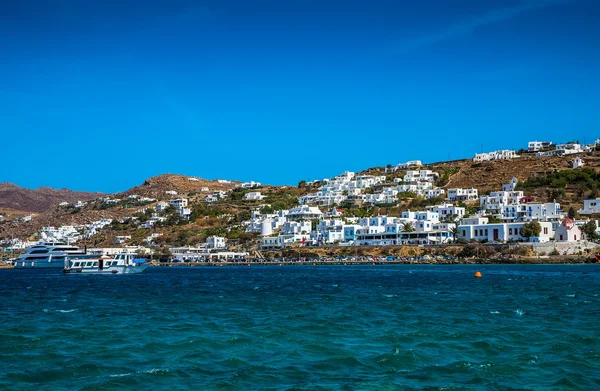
left=0, top=182, right=104, bottom=213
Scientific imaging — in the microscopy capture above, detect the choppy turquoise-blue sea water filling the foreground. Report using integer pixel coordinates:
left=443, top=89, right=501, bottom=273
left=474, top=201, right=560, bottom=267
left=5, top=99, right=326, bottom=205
left=0, top=265, right=600, bottom=390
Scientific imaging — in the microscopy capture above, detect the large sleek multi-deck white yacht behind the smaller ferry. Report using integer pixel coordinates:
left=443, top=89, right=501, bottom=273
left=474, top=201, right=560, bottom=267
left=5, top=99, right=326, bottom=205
left=13, top=242, right=98, bottom=269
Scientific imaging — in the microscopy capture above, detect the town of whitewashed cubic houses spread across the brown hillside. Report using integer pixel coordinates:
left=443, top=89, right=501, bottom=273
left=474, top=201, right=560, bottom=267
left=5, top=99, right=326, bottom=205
left=0, top=139, right=600, bottom=261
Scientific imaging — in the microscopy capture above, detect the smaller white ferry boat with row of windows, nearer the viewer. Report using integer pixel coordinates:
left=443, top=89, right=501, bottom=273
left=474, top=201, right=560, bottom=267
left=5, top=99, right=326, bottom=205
left=63, top=254, right=150, bottom=274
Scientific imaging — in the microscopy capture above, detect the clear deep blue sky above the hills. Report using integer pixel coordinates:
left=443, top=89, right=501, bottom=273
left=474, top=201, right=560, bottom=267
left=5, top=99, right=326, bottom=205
left=0, top=0, right=600, bottom=192
